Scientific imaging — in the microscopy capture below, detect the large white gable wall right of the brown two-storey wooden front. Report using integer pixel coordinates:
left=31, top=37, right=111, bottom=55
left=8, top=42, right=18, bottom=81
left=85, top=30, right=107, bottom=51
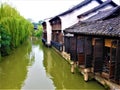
left=60, top=1, right=99, bottom=30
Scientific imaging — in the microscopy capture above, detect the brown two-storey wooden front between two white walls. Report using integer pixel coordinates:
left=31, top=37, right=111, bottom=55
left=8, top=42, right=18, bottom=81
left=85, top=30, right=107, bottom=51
left=49, top=17, right=63, bottom=51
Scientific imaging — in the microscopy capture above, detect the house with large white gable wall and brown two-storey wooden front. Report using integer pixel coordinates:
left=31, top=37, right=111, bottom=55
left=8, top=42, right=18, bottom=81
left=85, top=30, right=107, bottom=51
left=49, top=0, right=103, bottom=51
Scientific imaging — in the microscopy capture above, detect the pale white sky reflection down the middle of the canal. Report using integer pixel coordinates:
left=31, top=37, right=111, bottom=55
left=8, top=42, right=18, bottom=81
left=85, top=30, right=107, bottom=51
left=22, top=40, right=54, bottom=89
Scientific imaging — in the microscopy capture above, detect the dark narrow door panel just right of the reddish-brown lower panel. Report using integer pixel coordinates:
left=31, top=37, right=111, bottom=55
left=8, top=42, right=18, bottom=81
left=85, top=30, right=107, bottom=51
left=85, top=37, right=92, bottom=68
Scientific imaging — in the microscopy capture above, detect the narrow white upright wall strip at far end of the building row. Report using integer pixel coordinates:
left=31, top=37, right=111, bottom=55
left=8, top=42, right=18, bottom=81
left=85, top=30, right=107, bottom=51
left=46, top=20, right=51, bottom=47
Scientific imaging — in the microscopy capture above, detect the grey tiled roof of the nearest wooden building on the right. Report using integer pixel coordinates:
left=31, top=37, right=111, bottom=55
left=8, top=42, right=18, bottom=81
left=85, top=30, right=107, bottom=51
left=64, top=7, right=120, bottom=38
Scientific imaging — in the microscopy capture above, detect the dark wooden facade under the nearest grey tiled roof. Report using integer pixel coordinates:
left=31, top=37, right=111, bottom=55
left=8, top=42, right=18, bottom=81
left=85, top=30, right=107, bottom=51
left=65, top=35, right=120, bottom=83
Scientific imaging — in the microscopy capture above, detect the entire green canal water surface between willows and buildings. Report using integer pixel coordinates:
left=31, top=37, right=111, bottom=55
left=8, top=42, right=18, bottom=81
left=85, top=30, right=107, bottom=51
left=0, top=39, right=105, bottom=90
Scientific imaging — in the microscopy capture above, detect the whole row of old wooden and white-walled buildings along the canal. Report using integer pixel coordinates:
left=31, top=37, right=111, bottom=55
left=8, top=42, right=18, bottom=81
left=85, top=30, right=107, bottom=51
left=42, top=0, right=120, bottom=89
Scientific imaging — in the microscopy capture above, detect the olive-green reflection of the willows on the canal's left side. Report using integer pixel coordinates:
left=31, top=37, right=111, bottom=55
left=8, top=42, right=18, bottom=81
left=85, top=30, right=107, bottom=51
left=0, top=41, right=31, bottom=89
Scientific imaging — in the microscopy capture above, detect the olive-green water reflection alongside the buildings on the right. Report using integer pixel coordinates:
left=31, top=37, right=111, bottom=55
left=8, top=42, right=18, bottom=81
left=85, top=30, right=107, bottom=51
left=43, top=47, right=104, bottom=90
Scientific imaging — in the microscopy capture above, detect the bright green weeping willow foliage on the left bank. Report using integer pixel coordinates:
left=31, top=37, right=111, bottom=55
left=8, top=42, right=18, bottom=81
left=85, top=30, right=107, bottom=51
left=0, top=4, right=33, bottom=56
